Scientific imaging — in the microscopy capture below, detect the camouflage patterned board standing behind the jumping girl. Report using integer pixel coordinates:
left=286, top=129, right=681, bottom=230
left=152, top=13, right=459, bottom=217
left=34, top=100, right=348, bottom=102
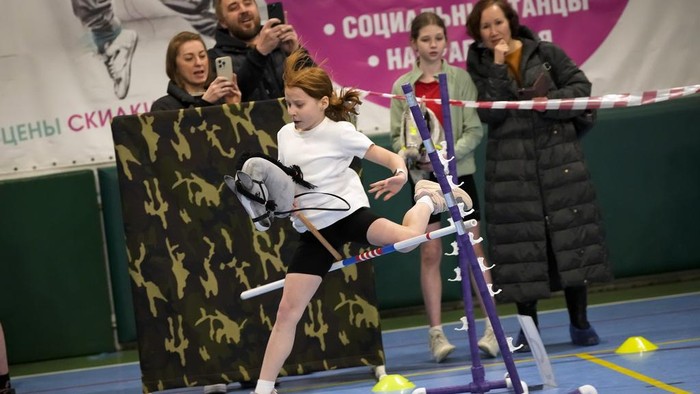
left=112, top=100, right=384, bottom=392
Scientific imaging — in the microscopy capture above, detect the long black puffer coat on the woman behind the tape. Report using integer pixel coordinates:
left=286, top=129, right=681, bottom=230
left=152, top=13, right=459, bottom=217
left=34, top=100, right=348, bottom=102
left=467, top=27, right=612, bottom=302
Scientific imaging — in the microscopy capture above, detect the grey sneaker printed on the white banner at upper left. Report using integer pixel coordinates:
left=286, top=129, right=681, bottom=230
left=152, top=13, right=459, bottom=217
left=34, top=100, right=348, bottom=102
left=103, top=29, right=139, bottom=100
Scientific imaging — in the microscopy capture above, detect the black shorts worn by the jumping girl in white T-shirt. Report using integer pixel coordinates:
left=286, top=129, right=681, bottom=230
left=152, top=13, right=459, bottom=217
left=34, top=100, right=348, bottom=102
left=287, top=208, right=380, bottom=278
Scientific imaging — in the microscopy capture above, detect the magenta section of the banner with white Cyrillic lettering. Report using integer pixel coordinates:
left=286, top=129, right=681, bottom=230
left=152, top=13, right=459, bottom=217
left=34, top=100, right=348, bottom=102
left=284, top=0, right=628, bottom=106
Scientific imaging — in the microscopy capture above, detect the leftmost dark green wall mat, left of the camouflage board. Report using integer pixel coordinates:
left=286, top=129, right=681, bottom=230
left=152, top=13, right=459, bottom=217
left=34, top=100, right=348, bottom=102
left=0, top=171, right=114, bottom=364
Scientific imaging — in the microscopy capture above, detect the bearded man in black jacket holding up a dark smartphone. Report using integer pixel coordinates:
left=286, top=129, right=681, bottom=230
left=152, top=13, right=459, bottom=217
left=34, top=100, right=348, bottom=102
left=209, top=0, right=306, bottom=101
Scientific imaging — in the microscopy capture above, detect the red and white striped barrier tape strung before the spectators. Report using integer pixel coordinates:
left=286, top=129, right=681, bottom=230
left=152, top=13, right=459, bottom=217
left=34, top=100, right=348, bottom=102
left=358, top=85, right=700, bottom=111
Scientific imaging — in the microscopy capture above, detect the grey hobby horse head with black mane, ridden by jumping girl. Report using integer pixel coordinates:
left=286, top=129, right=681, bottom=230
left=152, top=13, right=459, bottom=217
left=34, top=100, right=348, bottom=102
left=224, top=153, right=316, bottom=231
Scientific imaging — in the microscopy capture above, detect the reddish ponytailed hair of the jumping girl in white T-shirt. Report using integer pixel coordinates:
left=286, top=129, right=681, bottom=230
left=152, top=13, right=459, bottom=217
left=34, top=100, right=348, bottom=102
left=284, top=49, right=362, bottom=122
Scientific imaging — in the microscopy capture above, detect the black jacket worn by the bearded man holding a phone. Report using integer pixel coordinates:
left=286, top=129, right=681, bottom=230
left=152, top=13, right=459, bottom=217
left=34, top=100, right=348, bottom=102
left=209, top=27, right=287, bottom=101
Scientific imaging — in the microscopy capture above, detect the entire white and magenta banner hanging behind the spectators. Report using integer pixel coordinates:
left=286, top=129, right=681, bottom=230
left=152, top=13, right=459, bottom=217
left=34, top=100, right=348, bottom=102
left=5, top=0, right=700, bottom=179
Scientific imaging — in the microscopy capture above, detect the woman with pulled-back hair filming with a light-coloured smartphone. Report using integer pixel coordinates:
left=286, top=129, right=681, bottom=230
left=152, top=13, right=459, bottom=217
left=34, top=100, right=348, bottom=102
left=151, top=31, right=241, bottom=111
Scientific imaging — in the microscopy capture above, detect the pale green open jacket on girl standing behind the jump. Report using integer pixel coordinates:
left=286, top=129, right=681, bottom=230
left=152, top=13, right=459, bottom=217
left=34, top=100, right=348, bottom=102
left=390, top=61, right=484, bottom=175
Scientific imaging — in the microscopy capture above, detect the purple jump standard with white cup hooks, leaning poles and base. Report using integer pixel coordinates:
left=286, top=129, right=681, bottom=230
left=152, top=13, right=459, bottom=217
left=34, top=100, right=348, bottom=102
left=402, top=78, right=527, bottom=394
